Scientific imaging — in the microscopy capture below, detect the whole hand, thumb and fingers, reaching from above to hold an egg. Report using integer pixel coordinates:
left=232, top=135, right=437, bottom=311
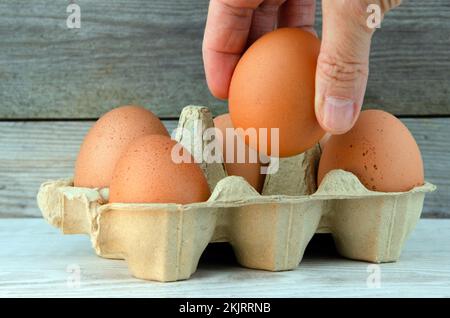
left=203, top=0, right=401, bottom=134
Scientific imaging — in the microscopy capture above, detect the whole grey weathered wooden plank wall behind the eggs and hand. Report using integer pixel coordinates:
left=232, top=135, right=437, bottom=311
left=0, top=0, right=450, bottom=217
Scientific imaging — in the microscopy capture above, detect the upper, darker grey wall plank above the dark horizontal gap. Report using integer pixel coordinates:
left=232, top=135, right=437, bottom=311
left=0, top=0, right=450, bottom=118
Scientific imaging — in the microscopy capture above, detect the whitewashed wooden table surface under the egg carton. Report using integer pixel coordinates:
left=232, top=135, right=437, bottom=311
left=0, top=219, right=450, bottom=297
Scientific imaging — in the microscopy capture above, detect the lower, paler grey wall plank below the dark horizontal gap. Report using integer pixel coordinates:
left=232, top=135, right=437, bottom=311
left=0, top=118, right=450, bottom=217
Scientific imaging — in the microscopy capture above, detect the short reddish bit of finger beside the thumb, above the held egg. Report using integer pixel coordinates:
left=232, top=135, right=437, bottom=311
left=278, top=0, right=316, bottom=34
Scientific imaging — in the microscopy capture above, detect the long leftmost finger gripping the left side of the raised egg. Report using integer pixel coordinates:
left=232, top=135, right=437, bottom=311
left=202, top=0, right=262, bottom=99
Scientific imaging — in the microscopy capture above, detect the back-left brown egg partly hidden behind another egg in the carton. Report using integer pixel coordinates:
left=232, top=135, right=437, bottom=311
left=74, top=105, right=169, bottom=188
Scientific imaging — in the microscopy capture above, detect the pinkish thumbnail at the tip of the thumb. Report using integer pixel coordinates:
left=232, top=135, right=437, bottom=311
left=323, top=96, right=355, bottom=133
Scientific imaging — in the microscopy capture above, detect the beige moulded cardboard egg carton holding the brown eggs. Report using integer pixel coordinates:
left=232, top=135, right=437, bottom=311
left=37, top=106, right=435, bottom=281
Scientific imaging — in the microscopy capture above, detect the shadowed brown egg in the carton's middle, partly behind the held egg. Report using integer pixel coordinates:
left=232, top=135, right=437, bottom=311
left=214, top=114, right=265, bottom=192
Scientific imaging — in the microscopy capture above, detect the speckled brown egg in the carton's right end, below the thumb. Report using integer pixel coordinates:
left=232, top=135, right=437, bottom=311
left=318, top=110, right=424, bottom=192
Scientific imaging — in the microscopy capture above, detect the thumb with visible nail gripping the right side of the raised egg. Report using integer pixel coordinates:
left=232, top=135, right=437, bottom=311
left=315, top=0, right=374, bottom=134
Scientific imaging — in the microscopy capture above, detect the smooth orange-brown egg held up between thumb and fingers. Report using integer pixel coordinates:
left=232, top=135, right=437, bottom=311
left=229, top=28, right=325, bottom=157
